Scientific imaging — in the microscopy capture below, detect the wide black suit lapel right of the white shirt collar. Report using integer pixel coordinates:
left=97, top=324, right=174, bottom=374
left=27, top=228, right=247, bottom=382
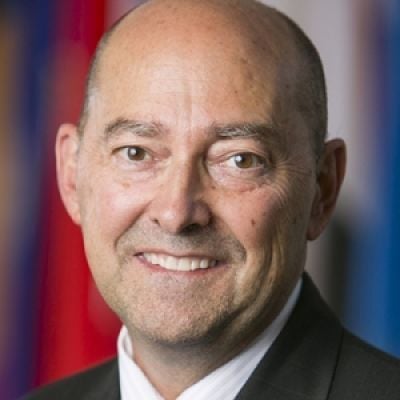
left=237, top=275, right=343, bottom=400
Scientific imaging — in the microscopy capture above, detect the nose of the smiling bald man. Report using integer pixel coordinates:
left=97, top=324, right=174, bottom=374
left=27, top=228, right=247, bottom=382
left=148, top=162, right=211, bottom=234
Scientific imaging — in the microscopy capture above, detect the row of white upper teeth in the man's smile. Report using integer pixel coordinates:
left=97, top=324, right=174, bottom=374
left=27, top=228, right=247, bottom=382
left=143, top=253, right=217, bottom=271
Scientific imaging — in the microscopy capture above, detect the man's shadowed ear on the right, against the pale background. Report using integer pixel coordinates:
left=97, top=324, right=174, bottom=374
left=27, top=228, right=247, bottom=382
left=307, top=139, right=346, bottom=240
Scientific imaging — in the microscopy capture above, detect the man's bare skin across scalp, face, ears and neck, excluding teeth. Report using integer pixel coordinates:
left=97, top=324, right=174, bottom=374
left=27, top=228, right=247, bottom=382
left=56, top=1, right=345, bottom=399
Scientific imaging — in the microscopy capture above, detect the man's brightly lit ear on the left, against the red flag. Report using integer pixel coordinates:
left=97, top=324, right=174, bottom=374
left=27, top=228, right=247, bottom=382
left=55, top=124, right=80, bottom=224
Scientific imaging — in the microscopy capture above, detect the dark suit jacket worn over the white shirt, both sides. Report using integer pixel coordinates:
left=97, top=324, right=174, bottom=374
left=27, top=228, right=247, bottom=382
left=21, top=276, right=400, bottom=400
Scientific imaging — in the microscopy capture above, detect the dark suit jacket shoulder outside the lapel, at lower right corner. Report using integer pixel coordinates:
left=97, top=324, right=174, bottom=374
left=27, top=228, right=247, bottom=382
left=330, top=331, right=400, bottom=400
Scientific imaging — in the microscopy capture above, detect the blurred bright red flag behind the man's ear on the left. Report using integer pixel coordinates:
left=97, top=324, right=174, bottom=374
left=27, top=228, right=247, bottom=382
left=35, top=0, right=120, bottom=385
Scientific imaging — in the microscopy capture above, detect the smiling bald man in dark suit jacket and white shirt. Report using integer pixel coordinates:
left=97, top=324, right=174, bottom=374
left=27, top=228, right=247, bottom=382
left=23, top=0, right=400, bottom=400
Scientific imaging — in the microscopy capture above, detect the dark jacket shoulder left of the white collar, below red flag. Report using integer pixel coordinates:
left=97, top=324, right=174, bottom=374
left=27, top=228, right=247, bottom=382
left=21, top=359, right=119, bottom=400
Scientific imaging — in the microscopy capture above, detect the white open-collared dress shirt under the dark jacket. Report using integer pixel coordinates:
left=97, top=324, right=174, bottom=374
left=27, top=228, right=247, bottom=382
left=117, top=280, right=301, bottom=400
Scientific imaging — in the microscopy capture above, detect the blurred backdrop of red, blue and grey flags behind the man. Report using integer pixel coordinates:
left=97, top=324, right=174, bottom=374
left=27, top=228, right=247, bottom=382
left=0, top=0, right=400, bottom=400
